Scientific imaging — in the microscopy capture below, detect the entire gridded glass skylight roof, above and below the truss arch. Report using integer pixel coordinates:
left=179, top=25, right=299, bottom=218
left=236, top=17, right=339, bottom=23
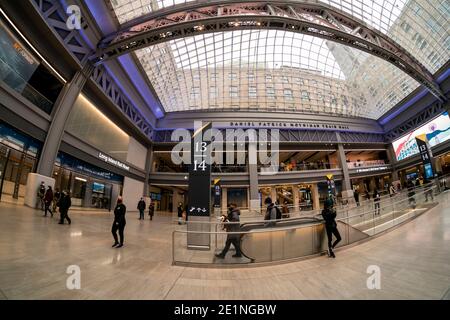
left=111, top=0, right=450, bottom=119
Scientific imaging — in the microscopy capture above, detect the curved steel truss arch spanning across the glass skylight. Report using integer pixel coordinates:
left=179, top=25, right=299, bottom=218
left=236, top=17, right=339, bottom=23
left=96, top=0, right=446, bottom=101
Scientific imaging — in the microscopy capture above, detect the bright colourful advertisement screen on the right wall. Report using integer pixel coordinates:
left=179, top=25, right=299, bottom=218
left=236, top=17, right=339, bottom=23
left=392, top=112, right=450, bottom=161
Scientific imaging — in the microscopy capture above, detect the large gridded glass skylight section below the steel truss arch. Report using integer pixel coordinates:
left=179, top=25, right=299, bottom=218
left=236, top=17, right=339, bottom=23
left=136, top=30, right=418, bottom=119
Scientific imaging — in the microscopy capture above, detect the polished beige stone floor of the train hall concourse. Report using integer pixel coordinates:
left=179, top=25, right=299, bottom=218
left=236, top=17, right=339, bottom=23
left=0, top=195, right=450, bottom=299
